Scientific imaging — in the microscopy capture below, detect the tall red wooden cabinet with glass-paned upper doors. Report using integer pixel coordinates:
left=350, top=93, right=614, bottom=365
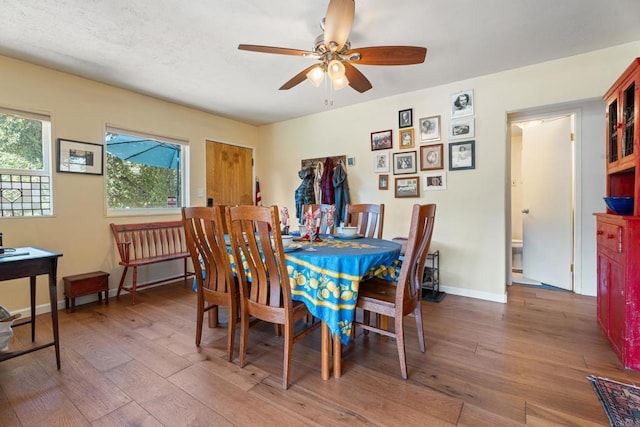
left=595, top=58, right=640, bottom=370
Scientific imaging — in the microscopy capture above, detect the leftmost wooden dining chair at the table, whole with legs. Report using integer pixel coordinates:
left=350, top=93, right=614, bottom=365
left=182, top=206, right=239, bottom=361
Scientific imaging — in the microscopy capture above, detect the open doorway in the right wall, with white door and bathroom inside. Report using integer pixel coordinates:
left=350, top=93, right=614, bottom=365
left=509, top=112, right=576, bottom=291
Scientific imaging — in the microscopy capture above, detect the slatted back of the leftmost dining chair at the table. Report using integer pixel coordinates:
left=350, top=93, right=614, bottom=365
left=182, top=206, right=236, bottom=298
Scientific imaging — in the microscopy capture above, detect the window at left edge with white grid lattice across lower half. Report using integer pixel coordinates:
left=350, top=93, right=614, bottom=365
left=0, top=108, right=53, bottom=217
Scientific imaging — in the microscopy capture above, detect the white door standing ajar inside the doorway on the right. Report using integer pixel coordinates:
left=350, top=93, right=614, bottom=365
left=522, top=117, right=573, bottom=290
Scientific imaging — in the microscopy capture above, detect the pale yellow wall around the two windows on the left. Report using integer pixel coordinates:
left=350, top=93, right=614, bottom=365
left=0, top=56, right=259, bottom=311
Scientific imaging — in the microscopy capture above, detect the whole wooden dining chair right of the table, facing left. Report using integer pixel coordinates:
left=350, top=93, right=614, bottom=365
left=354, top=204, right=436, bottom=380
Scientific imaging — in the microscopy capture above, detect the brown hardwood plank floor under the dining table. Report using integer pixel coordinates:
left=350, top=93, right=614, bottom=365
left=0, top=284, right=640, bottom=427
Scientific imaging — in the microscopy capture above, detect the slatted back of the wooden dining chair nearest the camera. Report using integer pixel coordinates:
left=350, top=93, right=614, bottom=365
left=227, top=206, right=292, bottom=323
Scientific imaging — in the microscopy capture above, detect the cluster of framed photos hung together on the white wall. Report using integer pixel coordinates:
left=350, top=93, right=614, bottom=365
left=371, top=89, right=476, bottom=198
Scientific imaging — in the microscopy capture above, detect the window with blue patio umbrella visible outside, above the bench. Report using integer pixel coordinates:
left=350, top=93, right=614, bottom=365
left=105, top=126, right=187, bottom=212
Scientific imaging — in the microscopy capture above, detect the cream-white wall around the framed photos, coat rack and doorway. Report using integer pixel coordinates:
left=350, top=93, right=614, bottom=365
left=257, top=42, right=640, bottom=301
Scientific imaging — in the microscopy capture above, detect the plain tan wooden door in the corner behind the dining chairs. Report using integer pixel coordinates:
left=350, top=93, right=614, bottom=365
left=206, top=141, right=253, bottom=206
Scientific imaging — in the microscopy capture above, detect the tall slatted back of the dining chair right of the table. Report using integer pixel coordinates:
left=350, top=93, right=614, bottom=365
left=396, top=203, right=436, bottom=316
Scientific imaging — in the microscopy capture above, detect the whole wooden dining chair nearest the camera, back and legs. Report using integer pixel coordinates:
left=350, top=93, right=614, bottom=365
left=226, top=206, right=320, bottom=389
